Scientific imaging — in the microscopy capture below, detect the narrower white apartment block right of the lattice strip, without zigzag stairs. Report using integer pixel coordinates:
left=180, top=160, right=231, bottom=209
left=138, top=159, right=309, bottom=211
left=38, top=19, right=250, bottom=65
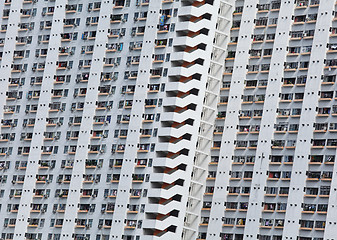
left=198, top=0, right=337, bottom=240
